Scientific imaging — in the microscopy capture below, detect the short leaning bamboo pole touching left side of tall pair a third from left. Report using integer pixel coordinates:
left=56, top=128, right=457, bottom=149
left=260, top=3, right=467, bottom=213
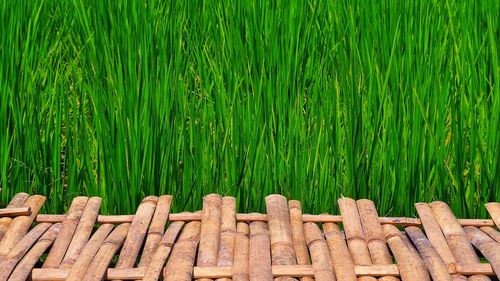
left=82, top=223, right=130, bottom=281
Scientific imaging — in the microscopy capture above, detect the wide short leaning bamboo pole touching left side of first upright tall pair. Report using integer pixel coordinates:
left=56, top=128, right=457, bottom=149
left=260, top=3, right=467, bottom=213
left=163, top=221, right=201, bottom=281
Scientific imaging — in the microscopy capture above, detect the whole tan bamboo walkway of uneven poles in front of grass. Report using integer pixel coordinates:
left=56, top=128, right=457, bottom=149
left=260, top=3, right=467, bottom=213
left=0, top=193, right=500, bottom=281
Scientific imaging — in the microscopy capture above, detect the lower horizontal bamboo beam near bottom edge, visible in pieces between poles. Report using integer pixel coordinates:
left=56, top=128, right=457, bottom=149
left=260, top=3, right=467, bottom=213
left=31, top=263, right=495, bottom=281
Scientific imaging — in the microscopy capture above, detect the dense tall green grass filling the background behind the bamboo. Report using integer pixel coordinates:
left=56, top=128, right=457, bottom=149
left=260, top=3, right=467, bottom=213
left=0, top=0, right=500, bottom=217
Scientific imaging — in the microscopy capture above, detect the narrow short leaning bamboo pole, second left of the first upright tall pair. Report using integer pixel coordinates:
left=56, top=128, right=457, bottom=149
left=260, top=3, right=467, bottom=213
left=142, top=221, right=184, bottom=281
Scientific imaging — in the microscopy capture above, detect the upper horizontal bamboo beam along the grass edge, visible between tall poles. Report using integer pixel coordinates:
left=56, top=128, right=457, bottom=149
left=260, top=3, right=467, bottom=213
left=32, top=213, right=495, bottom=227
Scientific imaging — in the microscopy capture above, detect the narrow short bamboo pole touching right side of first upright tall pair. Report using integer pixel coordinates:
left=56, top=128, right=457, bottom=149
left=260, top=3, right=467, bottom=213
left=232, top=222, right=250, bottom=281
